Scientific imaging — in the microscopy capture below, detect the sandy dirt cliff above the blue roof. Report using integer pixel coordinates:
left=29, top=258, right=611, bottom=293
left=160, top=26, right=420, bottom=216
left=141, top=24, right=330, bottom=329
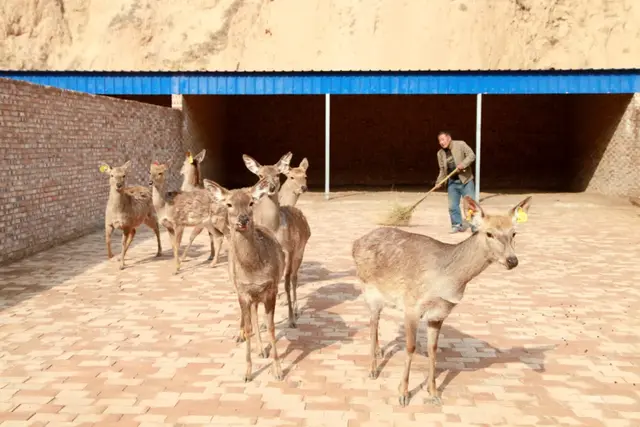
left=0, top=0, right=640, bottom=71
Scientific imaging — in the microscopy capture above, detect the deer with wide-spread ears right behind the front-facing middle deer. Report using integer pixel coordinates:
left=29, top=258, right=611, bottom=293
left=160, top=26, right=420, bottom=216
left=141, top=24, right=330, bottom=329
left=242, top=152, right=311, bottom=328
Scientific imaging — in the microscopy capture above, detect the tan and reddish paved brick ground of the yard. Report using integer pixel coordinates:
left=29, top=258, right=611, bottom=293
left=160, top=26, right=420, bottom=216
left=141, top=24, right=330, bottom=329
left=0, top=194, right=640, bottom=427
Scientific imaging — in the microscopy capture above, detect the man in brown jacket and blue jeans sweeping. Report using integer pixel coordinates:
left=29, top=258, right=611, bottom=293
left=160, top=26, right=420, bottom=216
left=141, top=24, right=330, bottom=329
left=436, top=131, right=476, bottom=233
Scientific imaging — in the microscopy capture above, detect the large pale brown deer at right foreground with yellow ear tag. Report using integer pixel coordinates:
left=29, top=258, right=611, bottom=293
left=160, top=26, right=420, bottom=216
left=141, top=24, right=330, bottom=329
left=352, top=196, right=531, bottom=406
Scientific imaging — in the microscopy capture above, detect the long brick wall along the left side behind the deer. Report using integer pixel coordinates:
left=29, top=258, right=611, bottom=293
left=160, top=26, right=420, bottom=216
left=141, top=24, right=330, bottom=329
left=0, top=79, right=182, bottom=263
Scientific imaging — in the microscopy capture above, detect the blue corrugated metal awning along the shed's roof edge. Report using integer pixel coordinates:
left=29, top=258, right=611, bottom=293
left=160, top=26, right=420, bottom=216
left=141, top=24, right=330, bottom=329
left=0, top=69, right=640, bottom=95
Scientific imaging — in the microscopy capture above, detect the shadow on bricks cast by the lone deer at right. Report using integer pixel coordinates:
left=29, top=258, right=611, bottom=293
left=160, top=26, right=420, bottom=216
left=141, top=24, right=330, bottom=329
left=378, top=324, right=555, bottom=399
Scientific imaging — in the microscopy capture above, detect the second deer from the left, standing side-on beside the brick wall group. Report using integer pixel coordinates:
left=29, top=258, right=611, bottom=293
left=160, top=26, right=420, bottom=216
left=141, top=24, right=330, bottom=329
left=149, top=162, right=228, bottom=274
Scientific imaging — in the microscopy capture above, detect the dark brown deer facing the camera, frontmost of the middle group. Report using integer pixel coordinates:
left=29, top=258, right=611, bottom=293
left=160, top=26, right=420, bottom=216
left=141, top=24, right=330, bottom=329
left=204, top=179, right=285, bottom=382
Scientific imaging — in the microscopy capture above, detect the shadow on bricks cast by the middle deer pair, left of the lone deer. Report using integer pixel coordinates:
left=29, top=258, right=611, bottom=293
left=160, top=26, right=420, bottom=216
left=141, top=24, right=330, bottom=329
left=256, top=283, right=360, bottom=376
